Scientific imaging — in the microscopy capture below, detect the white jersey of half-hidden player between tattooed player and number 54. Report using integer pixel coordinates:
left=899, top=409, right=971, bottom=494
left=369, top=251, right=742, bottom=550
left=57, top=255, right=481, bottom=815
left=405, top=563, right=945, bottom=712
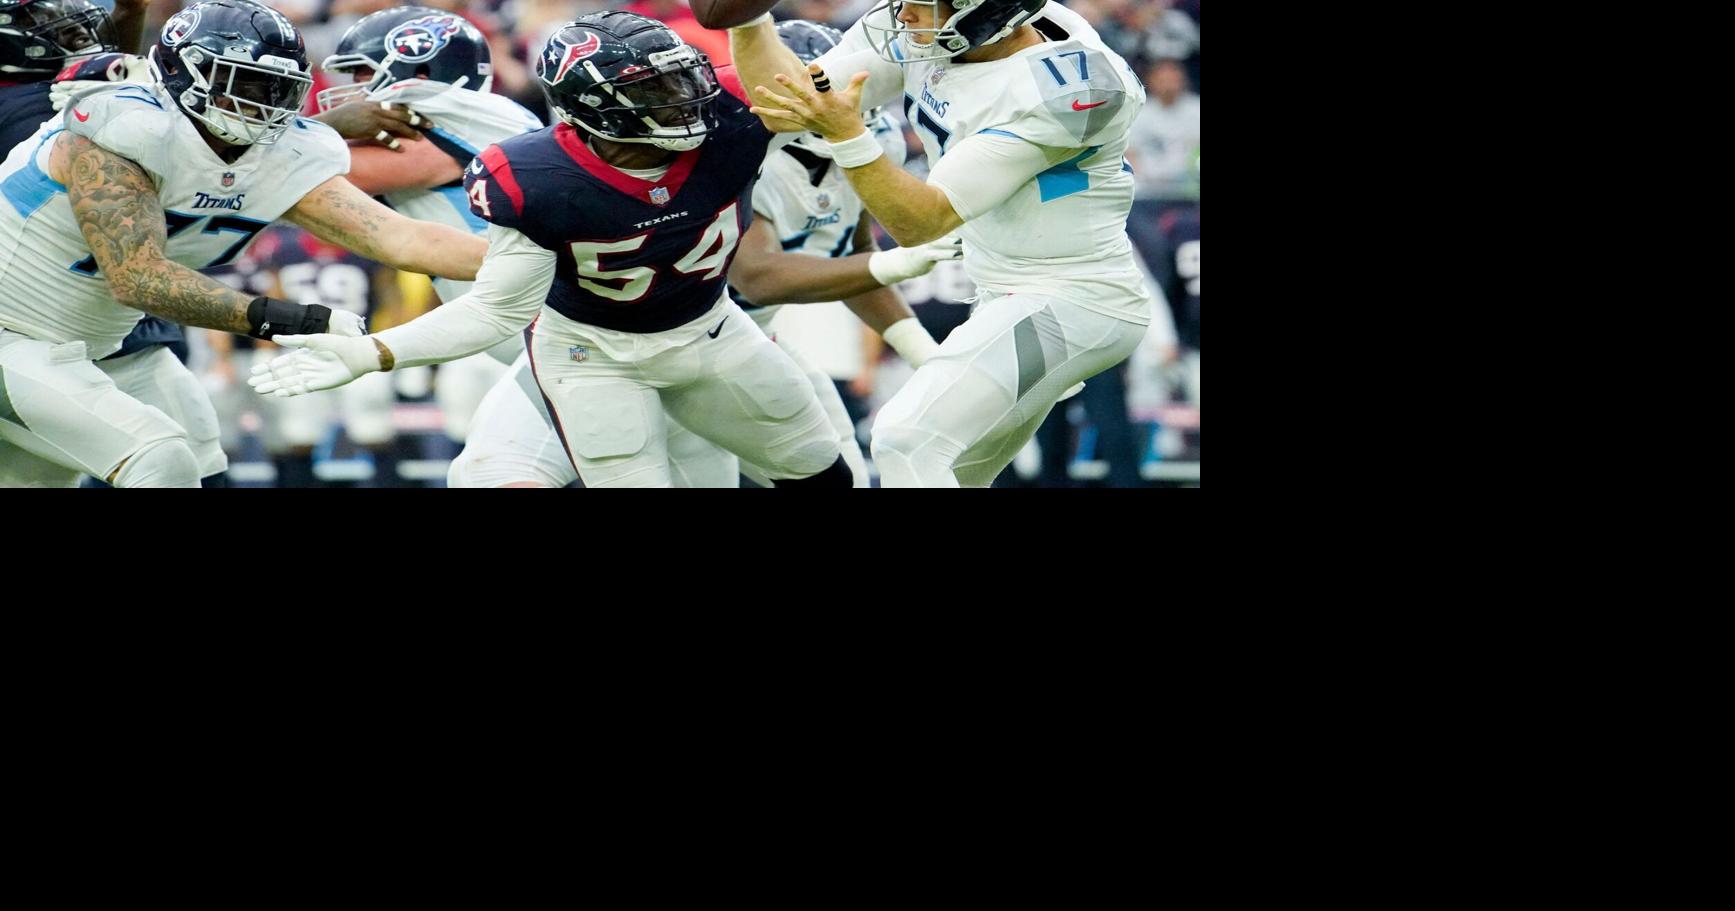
left=368, top=80, right=543, bottom=300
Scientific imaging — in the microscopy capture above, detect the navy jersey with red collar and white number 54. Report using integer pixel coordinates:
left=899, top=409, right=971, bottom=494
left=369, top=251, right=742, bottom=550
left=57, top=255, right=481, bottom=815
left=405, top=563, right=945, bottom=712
left=463, top=80, right=772, bottom=333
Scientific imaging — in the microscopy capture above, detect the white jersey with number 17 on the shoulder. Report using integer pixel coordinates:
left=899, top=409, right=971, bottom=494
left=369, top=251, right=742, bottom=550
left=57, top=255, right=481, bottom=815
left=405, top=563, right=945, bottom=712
left=819, top=2, right=1150, bottom=323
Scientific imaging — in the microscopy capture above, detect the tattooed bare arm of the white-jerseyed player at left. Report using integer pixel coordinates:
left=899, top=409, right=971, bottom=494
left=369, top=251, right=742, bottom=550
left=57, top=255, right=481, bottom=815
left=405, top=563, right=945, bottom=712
left=56, top=134, right=252, bottom=333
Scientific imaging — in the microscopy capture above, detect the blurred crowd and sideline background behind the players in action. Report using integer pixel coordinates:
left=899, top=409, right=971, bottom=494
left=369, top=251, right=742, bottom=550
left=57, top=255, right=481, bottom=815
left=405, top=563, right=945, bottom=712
left=84, top=0, right=1202, bottom=488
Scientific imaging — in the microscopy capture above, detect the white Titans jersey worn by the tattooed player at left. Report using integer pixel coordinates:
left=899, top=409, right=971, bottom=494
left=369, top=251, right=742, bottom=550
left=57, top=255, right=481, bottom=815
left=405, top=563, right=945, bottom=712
left=0, top=83, right=349, bottom=359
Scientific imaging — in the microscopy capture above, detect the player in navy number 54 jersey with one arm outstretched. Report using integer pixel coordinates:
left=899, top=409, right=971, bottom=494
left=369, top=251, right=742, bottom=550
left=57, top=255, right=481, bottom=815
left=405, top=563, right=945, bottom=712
left=250, top=12, right=867, bottom=488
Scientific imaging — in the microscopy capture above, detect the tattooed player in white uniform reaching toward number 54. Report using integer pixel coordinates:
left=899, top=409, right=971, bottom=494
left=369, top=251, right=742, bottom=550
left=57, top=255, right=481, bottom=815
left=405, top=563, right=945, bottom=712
left=0, top=0, right=486, bottom=488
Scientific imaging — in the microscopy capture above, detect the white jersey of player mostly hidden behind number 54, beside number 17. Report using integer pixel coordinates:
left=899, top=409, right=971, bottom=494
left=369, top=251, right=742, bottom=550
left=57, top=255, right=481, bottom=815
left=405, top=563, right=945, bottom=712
left=748, top=115, right=906, bottom=331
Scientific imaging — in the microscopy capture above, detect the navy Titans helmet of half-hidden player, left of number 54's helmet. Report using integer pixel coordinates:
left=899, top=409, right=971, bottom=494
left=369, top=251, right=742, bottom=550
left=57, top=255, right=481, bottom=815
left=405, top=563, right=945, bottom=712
left=319, top=7, right=494, bottom=111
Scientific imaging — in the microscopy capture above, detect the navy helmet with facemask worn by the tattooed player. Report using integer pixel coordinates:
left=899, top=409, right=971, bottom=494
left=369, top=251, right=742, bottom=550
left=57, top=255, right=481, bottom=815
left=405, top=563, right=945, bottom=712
left=151, top=0, right=314, bottom=146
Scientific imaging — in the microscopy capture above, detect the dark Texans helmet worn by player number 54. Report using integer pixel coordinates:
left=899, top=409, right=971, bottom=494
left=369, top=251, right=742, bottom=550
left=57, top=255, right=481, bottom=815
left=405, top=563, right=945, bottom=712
left=536, top=10, right=722, bottom=151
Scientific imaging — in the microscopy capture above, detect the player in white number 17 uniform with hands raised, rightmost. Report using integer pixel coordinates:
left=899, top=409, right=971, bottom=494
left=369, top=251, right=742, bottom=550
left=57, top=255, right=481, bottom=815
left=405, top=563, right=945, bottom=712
left=729, top=0, right=1152, bottom=488
